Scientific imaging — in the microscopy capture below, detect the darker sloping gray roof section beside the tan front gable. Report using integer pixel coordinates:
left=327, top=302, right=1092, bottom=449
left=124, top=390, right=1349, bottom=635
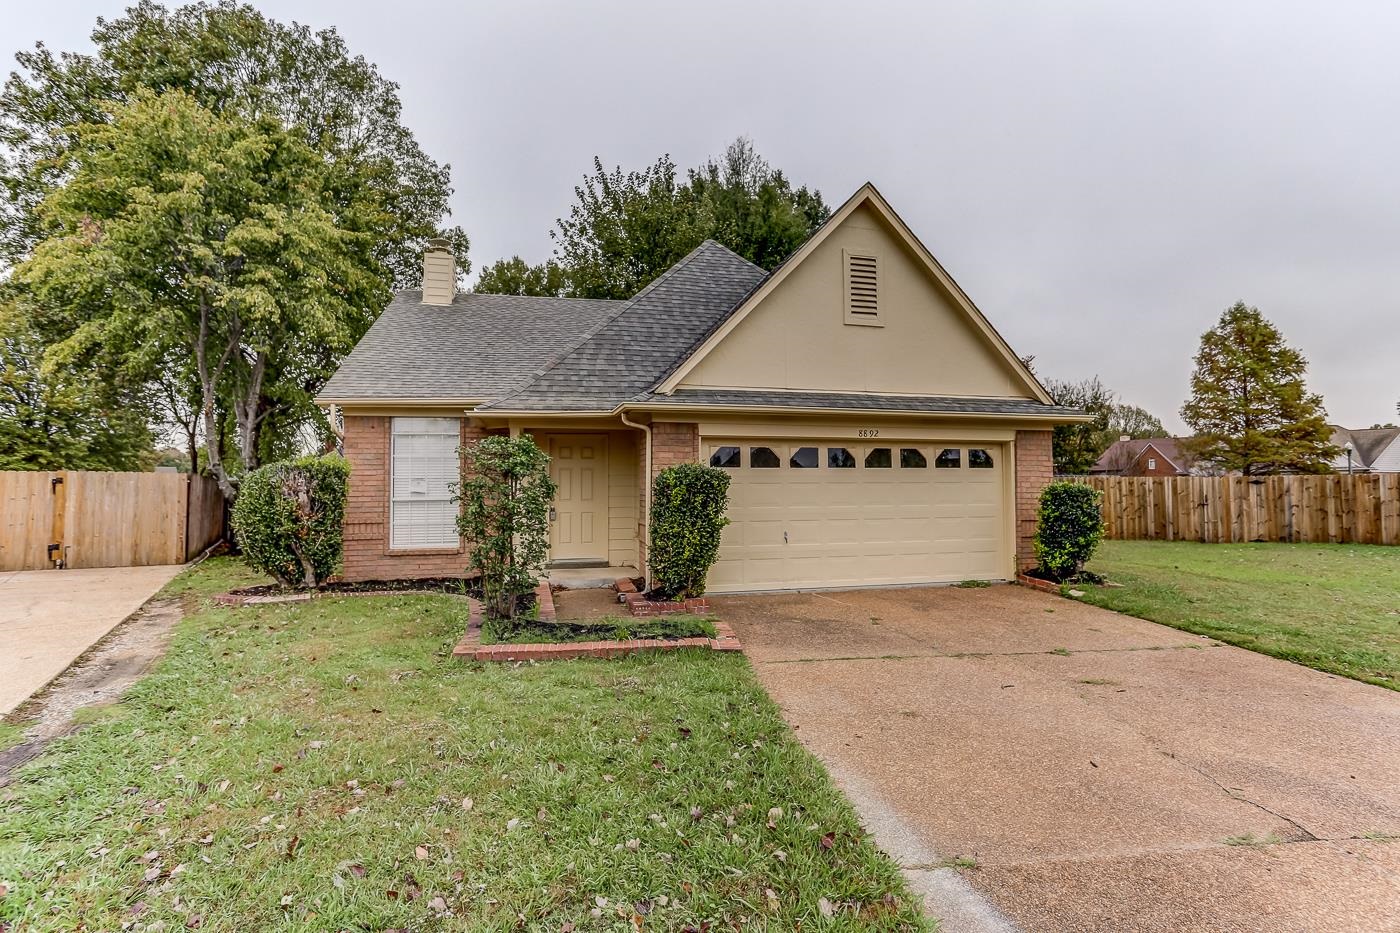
left=482, top=240, right=767, bottom=412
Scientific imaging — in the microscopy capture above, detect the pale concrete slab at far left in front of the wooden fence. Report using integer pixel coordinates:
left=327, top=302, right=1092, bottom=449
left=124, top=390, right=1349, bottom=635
left=0, top=565, right=183, bottom=716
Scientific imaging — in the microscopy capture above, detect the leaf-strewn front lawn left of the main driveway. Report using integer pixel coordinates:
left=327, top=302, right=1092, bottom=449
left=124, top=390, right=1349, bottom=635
left=0, top=560, right=924, bottom=933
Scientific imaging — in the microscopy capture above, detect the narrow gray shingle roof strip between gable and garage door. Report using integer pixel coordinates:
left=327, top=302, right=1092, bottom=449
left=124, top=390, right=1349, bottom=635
left=634, top=389, right=1084, bottom=417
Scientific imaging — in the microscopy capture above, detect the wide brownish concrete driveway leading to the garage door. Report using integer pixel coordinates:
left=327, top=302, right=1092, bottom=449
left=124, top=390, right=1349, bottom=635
left=713, top=586, right=1400, bottom=930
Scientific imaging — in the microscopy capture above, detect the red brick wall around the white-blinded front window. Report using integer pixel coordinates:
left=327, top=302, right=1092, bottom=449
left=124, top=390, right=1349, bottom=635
left=340, top=415, right=486, bottom=581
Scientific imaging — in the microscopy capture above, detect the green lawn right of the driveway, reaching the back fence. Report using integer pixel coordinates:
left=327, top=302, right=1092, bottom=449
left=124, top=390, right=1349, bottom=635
left=1081, top=541, right=1400, bottom=689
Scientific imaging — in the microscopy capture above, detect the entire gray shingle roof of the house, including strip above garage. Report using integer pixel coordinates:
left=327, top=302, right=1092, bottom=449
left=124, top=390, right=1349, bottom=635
left=321, top=240, right=1082, bottom=416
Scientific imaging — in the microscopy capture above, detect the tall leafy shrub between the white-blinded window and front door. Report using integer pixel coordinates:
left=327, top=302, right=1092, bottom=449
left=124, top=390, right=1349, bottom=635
left=456, top=436, right=556, bottom=619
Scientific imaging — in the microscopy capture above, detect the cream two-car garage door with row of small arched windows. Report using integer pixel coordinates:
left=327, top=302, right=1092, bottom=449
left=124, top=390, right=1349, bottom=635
left=701, top=437, right=1009, bottom=593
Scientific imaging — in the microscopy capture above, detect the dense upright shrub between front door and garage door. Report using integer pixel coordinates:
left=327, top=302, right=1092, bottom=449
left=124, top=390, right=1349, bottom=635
left=647, top=464, right=729, bottom=600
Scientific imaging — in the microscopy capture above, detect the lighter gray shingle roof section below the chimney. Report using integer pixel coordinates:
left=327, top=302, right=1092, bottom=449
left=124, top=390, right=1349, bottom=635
left=321, top=289, right=626, bottom=399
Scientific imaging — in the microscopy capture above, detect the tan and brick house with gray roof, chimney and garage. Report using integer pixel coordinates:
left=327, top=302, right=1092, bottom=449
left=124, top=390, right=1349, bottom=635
left=318, top=185, right=1088, bottom=593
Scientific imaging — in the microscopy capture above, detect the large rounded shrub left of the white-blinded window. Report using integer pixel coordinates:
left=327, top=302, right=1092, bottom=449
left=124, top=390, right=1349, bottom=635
left=230, top=454, right=350, bottom=590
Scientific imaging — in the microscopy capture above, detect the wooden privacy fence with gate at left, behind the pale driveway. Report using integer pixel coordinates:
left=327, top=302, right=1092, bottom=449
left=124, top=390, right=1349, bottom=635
left=0, top=471, right=224, bottom=570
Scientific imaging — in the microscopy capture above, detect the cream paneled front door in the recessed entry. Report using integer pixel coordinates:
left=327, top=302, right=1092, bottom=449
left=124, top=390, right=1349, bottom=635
left=546, top=434, right=608, bottom=560
